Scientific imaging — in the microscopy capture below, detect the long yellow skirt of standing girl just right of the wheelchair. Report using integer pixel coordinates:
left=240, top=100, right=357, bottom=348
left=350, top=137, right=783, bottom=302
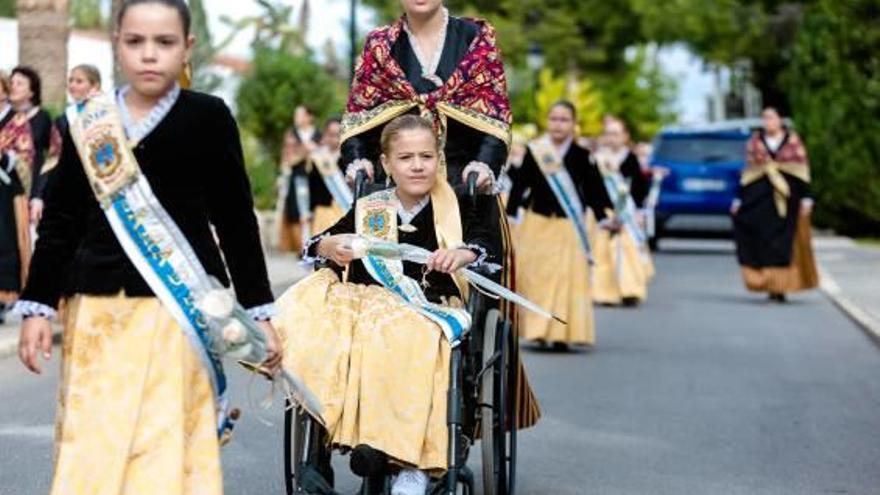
left=516, top=211, right=596, bottom=345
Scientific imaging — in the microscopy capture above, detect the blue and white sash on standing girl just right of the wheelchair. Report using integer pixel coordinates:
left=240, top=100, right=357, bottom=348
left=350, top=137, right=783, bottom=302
left=529, top=136, right=592, bottom=262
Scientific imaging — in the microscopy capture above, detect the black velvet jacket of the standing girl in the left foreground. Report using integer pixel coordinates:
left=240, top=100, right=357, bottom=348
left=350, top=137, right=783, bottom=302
left=21, top=90, right=274, bottom=308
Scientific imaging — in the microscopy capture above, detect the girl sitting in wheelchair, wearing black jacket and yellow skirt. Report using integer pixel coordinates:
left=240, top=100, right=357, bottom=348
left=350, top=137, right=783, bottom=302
left=277, top=115, right=501, bottom=495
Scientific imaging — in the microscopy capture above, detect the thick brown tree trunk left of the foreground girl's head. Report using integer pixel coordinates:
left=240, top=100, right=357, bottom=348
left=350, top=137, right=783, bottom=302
left=16, top=0, right=70, bottom=106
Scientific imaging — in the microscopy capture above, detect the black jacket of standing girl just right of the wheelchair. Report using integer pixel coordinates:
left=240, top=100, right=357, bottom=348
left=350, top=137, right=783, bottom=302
left=507, top=143, right=613, bottom=220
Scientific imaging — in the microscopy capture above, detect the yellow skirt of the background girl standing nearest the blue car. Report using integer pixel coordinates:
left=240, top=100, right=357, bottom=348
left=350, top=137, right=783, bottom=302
left=587, top=212, right=654, bottom=305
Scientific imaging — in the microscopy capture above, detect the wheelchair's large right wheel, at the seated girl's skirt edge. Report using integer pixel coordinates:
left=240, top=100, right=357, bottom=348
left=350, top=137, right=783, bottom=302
left=480, top=309, right=517, bottom=495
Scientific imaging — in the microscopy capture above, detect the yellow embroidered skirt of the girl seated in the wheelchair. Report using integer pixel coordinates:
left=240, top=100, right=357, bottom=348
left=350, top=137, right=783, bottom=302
left=275, top=269, right=450, bottom=471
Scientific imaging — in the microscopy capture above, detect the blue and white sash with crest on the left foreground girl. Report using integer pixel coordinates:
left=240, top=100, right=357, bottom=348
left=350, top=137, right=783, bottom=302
left=68, top=92, right=288, bottom=436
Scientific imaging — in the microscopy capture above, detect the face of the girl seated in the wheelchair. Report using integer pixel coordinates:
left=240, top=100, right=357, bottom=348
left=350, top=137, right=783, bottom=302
left=382, top=129, right=440, bottom=201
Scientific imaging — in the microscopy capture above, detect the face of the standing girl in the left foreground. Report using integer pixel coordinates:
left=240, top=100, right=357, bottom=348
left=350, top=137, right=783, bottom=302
left=116, top=3, right=195, bottom=98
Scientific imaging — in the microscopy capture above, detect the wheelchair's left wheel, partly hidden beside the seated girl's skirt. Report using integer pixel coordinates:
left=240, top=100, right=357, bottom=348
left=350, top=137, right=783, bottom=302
left=284, top=404, right=332, bottom=495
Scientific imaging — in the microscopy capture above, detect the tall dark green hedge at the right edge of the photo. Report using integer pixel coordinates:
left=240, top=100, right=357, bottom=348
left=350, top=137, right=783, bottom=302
left=788, top=0, right=880, bottom=236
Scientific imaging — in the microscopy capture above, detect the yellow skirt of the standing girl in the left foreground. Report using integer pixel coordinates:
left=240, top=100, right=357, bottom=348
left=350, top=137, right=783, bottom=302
left=52, top=296, right=223, bottom=495
